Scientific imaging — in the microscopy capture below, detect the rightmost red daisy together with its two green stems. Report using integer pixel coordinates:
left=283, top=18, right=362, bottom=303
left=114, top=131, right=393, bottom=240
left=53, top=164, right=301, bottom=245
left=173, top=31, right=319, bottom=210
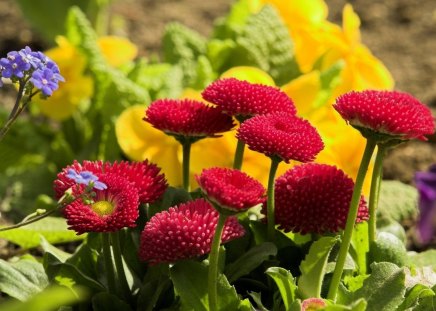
left=328, top=90, right=435, bottom=300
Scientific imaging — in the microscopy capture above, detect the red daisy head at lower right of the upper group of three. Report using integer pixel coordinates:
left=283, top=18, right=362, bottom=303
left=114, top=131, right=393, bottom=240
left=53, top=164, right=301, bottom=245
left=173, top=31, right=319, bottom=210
left=236, top=113, right=324, bottom=163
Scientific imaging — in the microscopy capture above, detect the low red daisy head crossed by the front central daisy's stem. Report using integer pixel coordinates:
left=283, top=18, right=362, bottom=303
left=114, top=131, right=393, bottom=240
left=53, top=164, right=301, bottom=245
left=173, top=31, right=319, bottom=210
left=139, top=199, right=245, bottom=264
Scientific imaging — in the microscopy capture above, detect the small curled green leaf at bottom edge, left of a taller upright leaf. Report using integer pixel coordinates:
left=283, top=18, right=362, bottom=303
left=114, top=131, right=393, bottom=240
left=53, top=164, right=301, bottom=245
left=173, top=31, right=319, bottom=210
left=265, top=267, right=297, bottom=310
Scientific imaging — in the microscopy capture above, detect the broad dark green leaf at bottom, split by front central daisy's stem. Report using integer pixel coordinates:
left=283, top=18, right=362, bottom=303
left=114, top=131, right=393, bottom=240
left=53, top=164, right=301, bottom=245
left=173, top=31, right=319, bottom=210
left=170, top=261, right=244, bottom=311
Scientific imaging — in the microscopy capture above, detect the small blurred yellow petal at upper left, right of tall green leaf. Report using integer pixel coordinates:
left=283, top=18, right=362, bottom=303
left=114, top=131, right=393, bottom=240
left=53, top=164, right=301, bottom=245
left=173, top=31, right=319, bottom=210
left=98, top=36, right=138, bottom=67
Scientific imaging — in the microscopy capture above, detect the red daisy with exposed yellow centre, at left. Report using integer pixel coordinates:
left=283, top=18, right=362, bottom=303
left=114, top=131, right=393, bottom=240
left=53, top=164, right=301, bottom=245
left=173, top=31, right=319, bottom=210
left=63, top=174, right=139, bottom=234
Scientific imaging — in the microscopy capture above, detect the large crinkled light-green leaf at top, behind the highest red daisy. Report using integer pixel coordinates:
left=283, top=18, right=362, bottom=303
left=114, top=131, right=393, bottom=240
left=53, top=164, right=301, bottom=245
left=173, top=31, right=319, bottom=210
left=229, top=5, right=301, bottom=85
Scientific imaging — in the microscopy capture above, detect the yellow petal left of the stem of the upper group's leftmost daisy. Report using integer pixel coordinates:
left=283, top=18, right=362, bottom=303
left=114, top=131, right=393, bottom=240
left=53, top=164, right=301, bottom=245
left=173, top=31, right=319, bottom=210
left=115, top=105, right=181, bottom=186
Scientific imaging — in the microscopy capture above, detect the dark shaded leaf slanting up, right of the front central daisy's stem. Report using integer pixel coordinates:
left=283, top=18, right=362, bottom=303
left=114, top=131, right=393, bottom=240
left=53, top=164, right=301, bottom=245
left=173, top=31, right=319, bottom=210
left=224, top=242, right=277, bottom=283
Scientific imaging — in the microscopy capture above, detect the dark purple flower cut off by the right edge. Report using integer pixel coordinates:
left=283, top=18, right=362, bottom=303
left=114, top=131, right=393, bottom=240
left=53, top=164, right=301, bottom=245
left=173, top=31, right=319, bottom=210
left=415, top=164, right=436, bottom=244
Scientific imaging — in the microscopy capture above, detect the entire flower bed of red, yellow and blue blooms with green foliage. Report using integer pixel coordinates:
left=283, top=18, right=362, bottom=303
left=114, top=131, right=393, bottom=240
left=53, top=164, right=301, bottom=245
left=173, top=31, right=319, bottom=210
left=0, top=0, right=436, bottom=311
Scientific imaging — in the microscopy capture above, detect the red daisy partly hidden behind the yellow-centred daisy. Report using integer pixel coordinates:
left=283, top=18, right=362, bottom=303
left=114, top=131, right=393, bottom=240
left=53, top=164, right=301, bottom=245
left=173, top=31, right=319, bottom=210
left=54, top=160, right=168, bottom=203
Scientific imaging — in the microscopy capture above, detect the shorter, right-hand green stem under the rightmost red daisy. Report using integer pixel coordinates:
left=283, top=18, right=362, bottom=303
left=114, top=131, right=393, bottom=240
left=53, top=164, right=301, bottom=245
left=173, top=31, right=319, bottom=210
left=368, top=145, right=386, bottom=244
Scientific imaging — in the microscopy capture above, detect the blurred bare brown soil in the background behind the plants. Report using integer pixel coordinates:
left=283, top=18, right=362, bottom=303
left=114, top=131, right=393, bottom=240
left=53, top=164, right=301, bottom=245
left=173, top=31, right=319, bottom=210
left=0, top=0, right=436, bottom=182
